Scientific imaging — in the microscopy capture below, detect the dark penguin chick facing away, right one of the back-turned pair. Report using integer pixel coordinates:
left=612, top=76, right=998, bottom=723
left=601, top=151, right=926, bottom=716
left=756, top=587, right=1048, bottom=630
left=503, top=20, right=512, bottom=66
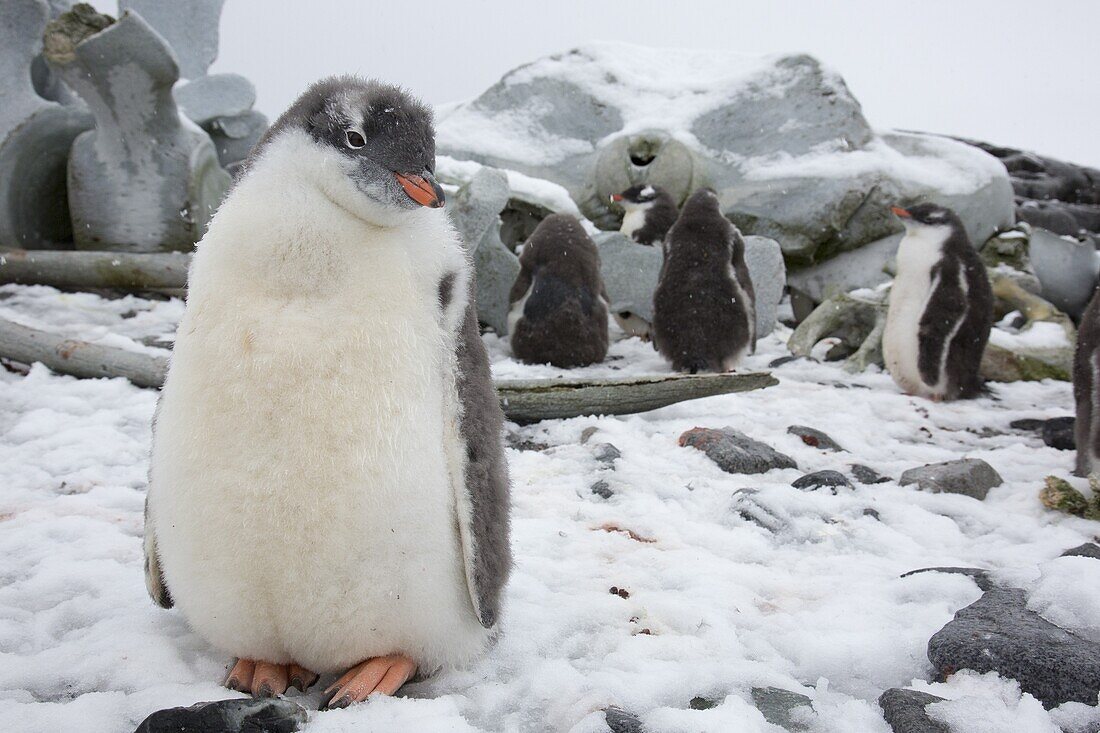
left=653, top=188, right=756, bottom=374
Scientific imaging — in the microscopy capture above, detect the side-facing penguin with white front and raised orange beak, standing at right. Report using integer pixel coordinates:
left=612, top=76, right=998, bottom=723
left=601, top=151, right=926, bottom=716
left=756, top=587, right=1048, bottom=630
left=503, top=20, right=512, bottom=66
left=882, top=204, right=993, bottom=402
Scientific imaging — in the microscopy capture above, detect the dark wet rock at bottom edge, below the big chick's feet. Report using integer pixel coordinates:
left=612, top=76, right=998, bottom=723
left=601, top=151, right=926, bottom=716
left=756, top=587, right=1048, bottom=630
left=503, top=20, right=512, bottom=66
left=134, top=698, right=307, bottom=733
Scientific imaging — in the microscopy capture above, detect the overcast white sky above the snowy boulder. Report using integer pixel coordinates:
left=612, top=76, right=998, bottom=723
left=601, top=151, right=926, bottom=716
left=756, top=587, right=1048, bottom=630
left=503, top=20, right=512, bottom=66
left=152, top=0, right=1100, bottom=167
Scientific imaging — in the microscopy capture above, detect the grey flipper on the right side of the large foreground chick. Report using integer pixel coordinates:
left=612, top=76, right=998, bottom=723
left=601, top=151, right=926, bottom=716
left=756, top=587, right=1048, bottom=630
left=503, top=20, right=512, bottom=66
left=455, top=278, right=512, bottom=628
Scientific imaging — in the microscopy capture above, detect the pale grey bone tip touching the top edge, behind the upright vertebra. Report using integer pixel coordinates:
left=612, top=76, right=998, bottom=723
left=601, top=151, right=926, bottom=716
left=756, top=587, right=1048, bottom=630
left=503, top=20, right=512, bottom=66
left=119, top=0, right=226, bottom=79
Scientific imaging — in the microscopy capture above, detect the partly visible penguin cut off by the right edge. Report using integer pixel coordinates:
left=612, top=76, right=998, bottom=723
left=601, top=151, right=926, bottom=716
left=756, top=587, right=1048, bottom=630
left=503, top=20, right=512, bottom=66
left=1074, top=281, right=1100, bottom=477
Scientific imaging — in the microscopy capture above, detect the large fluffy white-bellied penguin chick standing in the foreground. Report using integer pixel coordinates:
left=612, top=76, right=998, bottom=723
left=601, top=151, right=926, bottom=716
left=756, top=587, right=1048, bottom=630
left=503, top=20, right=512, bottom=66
left=145, top=77, right=510, bottom=707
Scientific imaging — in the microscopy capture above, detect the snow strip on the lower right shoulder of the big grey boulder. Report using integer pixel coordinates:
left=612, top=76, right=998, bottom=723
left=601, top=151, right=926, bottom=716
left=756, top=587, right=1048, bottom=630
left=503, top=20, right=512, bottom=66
left=738, top=132, right=1004, bottom=196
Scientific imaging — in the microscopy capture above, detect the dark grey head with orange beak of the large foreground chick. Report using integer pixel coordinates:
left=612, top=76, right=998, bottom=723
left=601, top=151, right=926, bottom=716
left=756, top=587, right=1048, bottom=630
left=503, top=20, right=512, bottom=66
left=251, top=76, right=444, bottom=211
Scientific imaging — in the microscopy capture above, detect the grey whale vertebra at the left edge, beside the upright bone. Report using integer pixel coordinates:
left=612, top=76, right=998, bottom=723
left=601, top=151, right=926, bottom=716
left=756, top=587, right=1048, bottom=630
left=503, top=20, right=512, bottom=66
left=0, top=0, right=92, bottom=249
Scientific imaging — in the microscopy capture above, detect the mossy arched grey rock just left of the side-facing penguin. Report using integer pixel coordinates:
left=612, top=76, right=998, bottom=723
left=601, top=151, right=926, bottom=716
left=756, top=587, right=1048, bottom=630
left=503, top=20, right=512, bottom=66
left=787, top=289, right=889, bottom=372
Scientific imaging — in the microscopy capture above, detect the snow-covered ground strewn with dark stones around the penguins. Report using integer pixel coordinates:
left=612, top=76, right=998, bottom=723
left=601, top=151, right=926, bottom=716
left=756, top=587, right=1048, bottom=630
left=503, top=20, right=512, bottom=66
left=0, top=286, right=1100, bottom=733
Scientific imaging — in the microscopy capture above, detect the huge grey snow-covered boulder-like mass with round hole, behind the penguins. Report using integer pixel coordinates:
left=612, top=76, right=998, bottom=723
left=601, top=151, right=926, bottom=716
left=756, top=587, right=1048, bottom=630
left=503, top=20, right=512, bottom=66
left=438, top=44, right=1014, bottom=283
